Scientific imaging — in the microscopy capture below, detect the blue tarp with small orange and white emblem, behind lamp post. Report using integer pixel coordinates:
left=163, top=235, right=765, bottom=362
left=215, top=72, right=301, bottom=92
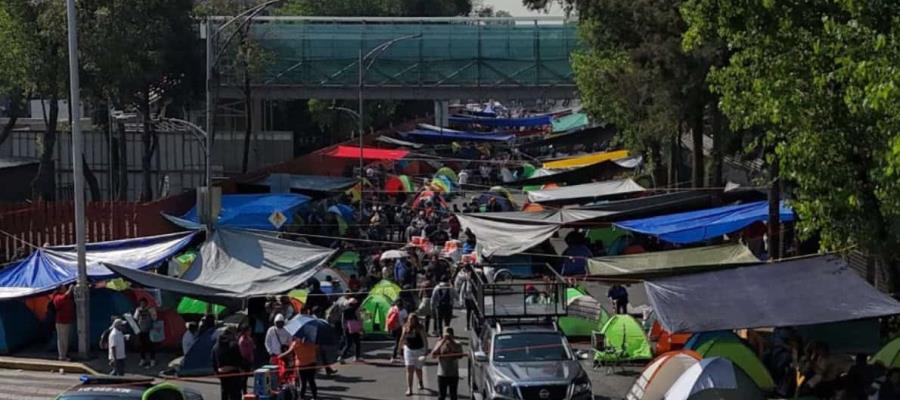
left=175, top=193, right=309, bottom=231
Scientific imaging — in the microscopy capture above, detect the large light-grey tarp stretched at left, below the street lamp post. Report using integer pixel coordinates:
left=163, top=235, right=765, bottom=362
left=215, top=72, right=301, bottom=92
left=110, top=229, right=336, bottom=305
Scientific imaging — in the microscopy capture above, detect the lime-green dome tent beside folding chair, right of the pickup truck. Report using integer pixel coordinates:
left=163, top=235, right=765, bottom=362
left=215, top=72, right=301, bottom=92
left=594, top=314, right=653, bottom=362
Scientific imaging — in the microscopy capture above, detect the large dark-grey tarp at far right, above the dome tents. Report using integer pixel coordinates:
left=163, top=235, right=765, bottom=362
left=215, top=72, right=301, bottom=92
left=644, top=256, right=900, bottom=332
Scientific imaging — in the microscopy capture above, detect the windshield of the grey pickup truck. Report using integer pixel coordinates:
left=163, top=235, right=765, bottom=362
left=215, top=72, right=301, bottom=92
left=494, top=333, right=570, bottom=362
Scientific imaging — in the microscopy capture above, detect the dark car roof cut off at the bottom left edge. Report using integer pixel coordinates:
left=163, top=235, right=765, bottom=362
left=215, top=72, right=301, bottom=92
left=56, top=376, right=203, bottom=400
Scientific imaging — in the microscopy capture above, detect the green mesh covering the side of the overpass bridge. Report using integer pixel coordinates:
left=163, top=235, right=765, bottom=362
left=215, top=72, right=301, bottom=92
left=224, top=18, right=578, bottom=87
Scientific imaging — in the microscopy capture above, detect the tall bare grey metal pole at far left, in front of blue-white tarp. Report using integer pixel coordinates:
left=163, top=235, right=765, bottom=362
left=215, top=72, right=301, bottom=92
left=66, top=0, right=90, bottom=358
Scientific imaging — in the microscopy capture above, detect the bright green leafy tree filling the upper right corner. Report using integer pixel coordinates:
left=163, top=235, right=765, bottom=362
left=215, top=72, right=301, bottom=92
left=683, top=0, right=900, bottom=288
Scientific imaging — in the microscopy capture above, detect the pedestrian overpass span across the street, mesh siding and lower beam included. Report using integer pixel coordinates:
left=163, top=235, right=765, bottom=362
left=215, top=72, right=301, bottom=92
left=219, top=17, right=579, bottom=100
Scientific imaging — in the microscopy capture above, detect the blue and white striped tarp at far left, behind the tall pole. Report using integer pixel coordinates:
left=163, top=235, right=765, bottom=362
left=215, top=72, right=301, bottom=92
left=0, top=232, right=195, bottom=299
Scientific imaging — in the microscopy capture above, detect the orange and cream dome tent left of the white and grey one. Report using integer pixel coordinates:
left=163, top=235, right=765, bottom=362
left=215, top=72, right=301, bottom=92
left=625, top=350, right=701, bottom=400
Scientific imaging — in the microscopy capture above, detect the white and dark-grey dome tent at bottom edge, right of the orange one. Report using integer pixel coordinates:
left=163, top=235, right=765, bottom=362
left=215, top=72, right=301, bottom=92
left=663, top=357, right=764, bottom=400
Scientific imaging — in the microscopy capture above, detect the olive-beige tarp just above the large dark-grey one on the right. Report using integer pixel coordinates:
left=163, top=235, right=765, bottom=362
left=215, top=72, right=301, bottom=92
left=587, top=244, right=760, bottom=279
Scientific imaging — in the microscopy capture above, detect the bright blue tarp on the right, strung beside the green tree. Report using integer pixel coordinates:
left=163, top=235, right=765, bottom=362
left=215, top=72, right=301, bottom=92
left=615, top=201, right=794, bottom=244
